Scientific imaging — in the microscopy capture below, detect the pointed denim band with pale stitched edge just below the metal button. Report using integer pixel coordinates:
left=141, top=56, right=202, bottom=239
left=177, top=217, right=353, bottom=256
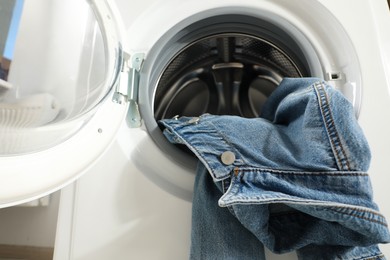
left=219, top=168, right=387, bottom=228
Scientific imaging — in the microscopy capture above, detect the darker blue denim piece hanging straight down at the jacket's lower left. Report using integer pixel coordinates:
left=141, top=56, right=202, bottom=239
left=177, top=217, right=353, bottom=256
left=190, top=164, right=265, bottom=260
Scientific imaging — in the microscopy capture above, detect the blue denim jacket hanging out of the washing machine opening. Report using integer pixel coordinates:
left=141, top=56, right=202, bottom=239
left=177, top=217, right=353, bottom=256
left=161, top=78, right=390, bottom=259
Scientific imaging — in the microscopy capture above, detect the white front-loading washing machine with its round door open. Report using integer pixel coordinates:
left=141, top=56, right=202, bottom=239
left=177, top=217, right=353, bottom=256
left=0, top=0, right=390, bottom=260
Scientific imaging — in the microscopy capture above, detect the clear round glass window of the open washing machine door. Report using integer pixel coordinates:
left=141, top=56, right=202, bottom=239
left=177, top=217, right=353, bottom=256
left=0, top=0, right=120, bottom=156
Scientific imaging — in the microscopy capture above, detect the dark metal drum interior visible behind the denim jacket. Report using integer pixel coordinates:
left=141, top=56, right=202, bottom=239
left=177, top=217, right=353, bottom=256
left=154, top=33, right=309, bottom=119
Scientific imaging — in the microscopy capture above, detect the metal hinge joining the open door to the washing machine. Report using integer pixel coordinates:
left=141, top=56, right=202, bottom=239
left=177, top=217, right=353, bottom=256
left=114, top=53, right=145, bottom=127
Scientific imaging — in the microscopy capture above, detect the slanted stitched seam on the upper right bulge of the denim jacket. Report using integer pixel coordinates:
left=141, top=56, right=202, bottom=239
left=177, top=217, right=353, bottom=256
left=313, top=82, right=350, bottom=170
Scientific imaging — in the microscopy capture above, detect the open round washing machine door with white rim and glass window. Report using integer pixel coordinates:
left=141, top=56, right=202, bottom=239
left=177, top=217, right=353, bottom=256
left=0, top=0, right=132, bottom=207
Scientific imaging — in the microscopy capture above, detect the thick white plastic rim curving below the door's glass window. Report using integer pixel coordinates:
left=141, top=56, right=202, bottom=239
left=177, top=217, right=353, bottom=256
left=0, top=95, right=126, bottom=207
